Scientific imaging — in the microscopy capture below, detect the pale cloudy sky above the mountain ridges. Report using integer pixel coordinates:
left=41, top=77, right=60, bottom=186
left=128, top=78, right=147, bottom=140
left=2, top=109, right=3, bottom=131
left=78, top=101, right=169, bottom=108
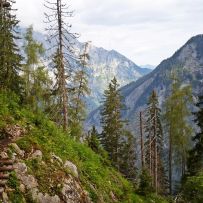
left=15, top=0, right=203, bottom=66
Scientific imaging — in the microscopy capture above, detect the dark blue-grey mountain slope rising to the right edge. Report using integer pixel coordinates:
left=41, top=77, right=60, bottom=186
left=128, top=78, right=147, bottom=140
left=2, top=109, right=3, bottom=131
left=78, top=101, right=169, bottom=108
left=86, top=35, right=203, bottom=128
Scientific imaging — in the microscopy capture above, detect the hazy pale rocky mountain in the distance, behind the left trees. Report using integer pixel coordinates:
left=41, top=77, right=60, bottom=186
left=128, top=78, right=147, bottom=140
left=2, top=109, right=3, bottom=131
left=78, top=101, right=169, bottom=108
left=18, top=27, right=151, bottom=112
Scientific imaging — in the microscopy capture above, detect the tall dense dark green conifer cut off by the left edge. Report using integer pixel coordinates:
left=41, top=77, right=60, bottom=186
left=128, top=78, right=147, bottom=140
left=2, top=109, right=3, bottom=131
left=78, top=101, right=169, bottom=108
left=0, top=0, right=22, bottom=94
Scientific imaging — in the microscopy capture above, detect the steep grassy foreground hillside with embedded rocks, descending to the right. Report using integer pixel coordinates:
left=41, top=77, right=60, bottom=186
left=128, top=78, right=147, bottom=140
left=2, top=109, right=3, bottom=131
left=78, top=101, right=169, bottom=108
left=0, top=93, right=166, bottom=203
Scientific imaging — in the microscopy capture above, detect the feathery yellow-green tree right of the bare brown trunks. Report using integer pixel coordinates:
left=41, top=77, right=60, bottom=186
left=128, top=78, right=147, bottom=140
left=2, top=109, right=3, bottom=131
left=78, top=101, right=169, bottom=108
left=164, top=78, right=192, bottom=194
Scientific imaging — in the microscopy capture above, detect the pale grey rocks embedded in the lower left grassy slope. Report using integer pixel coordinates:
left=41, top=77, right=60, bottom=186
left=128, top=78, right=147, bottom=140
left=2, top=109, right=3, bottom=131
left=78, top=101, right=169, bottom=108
left=4, top=143, right=91, bottom=203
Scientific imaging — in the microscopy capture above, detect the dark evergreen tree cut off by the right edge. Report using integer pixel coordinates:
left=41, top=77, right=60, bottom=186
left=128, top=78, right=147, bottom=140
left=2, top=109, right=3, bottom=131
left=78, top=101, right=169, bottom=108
left=187, top=96, right=203, bottom=176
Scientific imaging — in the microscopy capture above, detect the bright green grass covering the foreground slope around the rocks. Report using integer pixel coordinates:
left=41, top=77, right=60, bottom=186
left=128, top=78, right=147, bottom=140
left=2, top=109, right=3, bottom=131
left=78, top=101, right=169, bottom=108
left=0, top=93, right=166, bottom=203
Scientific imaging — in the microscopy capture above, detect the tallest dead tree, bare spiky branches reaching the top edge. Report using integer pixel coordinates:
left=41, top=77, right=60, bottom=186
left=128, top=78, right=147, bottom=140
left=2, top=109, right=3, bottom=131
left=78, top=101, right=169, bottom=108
left=45, top=0, right=78, bottom=130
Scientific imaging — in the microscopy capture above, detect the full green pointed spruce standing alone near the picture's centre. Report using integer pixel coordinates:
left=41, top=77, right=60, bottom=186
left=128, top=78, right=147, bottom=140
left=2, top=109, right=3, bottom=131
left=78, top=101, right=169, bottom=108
left=101, top=77, right=124, bottom=169
